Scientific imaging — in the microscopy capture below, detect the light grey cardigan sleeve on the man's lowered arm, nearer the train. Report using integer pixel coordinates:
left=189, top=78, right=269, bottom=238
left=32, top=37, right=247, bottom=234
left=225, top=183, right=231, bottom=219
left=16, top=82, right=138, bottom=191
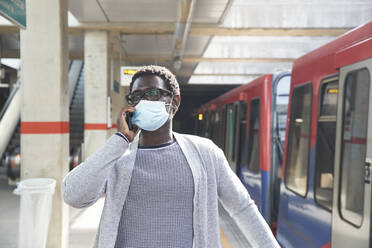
left=216, top=148, right=280, bottom=248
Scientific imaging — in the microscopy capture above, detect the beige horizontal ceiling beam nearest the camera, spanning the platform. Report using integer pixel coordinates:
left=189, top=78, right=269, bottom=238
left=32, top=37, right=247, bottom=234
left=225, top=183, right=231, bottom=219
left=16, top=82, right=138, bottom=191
left=0, top=22, right=351, bottom=37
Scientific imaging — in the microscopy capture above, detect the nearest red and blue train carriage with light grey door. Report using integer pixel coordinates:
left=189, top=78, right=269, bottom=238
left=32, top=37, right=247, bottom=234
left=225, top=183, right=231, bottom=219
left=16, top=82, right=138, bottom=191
left=277, top=22, right=372, bottom=247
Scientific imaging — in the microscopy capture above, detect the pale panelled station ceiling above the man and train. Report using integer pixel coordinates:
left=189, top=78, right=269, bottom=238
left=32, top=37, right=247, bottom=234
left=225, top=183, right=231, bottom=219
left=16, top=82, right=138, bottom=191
left=0, top=0, right=372, bottom=84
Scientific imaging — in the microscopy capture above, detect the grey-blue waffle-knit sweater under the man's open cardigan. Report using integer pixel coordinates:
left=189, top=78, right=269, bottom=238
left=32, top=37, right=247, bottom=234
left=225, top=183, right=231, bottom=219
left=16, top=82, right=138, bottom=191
left=115, top=141, right=194, bottom=248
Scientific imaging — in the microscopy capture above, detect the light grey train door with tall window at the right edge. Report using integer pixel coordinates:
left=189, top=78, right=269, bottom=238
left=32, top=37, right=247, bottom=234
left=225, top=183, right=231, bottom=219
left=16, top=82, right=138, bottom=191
left=331, top=59, right=372, bottom=248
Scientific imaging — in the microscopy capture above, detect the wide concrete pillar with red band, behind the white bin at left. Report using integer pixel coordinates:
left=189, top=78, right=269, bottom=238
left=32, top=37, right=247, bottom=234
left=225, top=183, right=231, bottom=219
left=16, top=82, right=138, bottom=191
left=20, top=0, right=69, bottom=248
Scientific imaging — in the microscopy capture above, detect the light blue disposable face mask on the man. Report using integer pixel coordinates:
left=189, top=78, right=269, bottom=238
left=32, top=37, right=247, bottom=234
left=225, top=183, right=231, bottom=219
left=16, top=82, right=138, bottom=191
left=132, top=100, right=169, bottom=131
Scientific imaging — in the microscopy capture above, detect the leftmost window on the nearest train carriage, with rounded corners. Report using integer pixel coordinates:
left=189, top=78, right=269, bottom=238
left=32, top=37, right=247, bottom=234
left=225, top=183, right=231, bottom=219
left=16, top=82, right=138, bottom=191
left=285, top=83, right=312, bottom=196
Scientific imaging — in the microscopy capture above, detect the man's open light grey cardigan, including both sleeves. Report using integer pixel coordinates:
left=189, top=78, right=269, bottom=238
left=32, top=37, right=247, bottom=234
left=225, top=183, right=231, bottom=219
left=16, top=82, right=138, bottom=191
left=62, top=133, right=280, bottom=248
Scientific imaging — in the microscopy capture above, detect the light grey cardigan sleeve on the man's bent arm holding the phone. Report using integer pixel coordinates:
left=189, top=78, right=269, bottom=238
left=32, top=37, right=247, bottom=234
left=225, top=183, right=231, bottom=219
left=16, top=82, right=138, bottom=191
left=61, top=135, right=129, bottom=208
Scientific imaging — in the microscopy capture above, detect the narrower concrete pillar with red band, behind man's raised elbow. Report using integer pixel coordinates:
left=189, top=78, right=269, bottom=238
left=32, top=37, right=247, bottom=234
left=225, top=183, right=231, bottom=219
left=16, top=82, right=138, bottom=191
left=84, top=31, right=110, bottom=158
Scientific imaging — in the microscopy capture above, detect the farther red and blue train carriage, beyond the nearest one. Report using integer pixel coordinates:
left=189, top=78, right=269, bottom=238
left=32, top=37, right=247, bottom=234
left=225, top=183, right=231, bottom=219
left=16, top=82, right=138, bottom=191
left=197, top=72, right=290, bottom=231
